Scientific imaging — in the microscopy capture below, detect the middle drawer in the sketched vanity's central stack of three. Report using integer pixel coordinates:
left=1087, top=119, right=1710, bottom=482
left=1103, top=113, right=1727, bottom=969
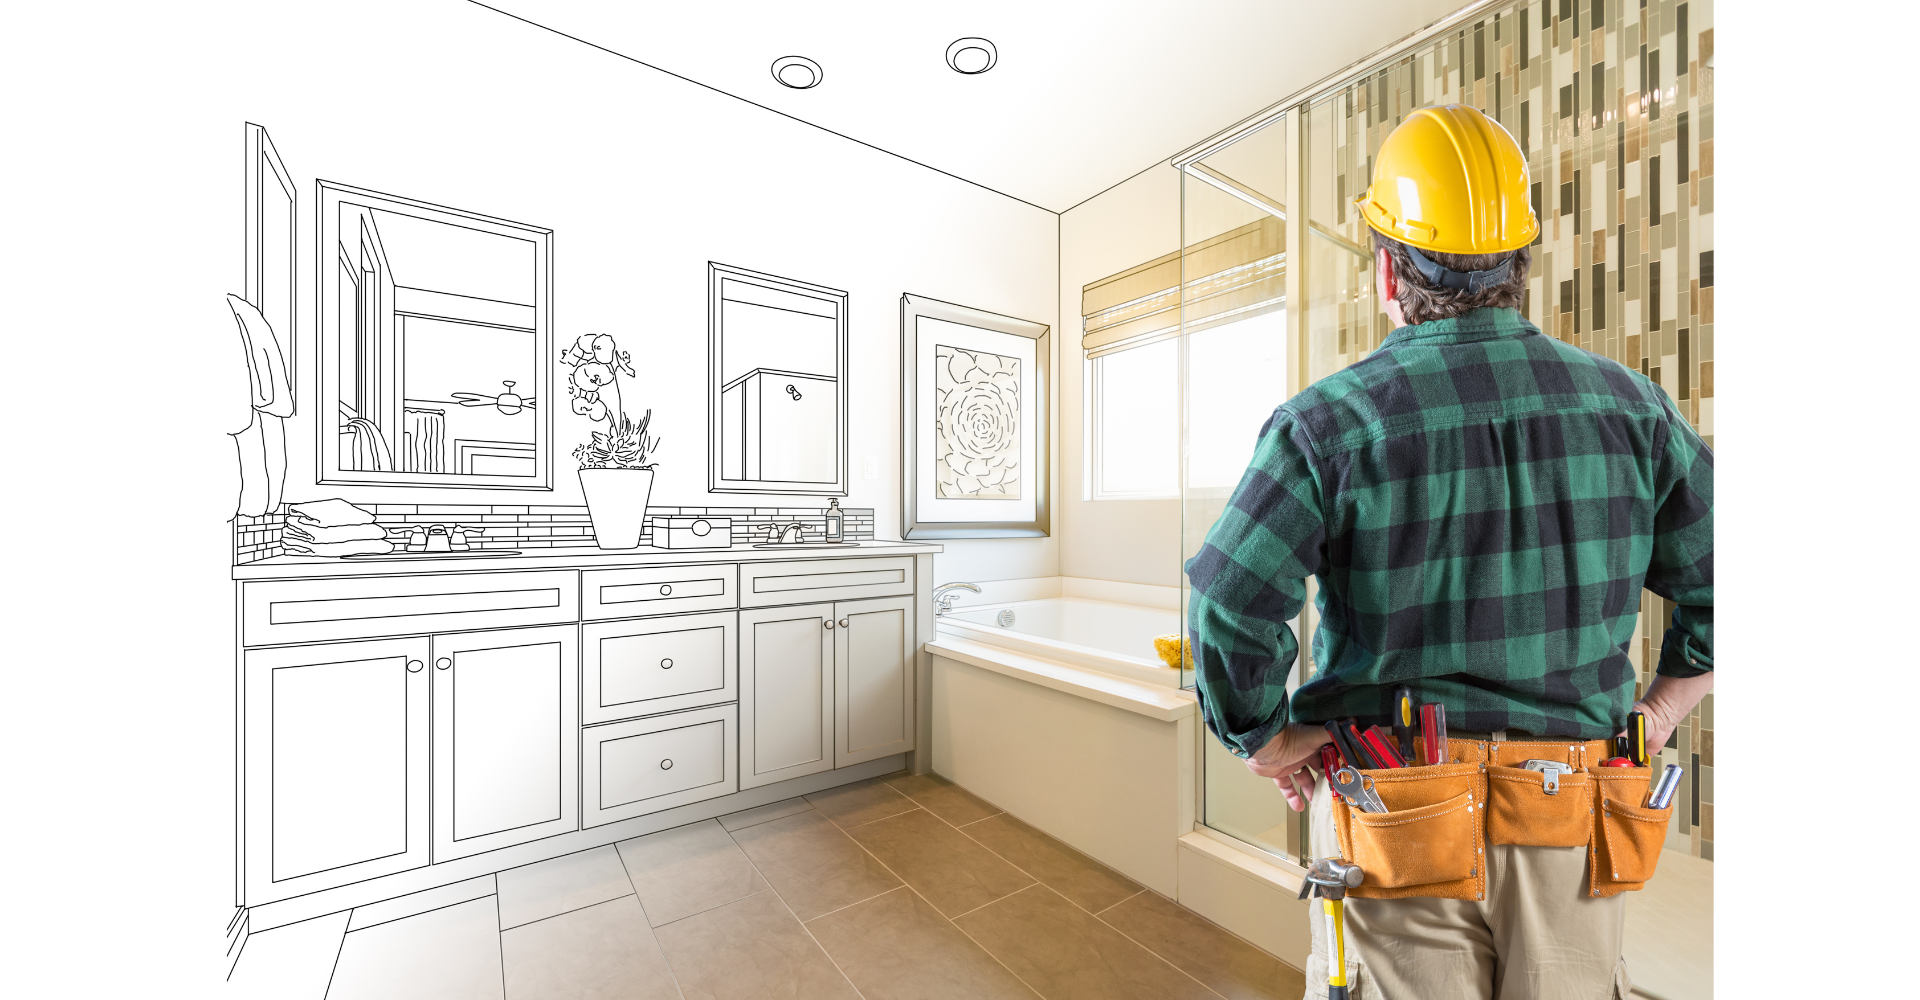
left=580, top=610, right=739, bottom=724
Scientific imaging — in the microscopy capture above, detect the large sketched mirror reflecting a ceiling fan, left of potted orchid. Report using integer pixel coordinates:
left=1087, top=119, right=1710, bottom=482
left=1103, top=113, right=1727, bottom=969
left=317, top=180, right=553, bottom=489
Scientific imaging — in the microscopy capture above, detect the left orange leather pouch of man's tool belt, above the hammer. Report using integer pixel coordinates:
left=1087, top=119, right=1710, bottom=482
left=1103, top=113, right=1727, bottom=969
left=1332, top=764, right=1486, bottom=900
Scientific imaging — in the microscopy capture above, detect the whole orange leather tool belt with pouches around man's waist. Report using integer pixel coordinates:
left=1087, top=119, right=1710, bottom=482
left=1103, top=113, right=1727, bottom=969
left=1332, top=739, right=1672, bottom=900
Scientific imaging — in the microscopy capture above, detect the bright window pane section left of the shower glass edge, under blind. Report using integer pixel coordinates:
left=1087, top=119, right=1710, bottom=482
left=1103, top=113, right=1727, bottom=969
left=1087, top=340, right=1181, bottom=499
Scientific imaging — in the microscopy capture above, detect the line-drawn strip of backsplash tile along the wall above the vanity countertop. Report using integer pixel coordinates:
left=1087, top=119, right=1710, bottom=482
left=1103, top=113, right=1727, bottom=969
left=234, top=503, right=874, bottom=566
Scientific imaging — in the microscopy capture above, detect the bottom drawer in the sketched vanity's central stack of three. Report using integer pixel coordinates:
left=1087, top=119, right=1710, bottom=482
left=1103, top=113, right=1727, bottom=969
left=580, top=704, right=739, bottom=827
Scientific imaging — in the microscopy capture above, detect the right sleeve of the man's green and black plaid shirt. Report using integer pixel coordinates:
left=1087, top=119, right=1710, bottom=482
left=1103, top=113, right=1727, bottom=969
left=1645, top=392, right=1713, bottom=678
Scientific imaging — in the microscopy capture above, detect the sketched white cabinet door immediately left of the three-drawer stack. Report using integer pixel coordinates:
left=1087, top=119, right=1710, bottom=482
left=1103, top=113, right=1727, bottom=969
left=432, top=626, right=580, bottom=864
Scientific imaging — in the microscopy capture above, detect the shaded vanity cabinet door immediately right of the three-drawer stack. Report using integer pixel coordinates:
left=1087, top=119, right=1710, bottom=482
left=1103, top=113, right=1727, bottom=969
left=739, top=605, right=833, bottom=789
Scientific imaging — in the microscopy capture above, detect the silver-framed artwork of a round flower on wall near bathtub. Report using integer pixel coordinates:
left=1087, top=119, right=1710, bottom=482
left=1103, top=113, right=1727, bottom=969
left=900, top=296, right=1052, bottom=537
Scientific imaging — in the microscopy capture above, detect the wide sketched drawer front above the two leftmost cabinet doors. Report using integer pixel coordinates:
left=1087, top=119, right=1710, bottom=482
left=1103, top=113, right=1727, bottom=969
left=242, top=570, right=580, bottom=645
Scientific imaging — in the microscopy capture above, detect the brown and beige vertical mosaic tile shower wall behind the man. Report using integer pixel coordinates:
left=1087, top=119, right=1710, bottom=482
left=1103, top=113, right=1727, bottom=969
left=1306, top=0, right=1715, bottom=860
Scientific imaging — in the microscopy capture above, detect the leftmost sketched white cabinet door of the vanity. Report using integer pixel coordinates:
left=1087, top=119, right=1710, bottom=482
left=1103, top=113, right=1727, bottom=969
left=242, top=637, right=428, bottom=906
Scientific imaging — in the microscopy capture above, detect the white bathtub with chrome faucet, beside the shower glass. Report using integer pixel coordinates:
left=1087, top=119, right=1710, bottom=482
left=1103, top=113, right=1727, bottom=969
left=935, top=597, right=1181, bottom=687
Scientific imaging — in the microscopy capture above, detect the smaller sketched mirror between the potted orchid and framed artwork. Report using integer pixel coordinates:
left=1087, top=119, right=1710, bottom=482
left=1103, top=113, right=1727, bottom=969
left=707, top=263, right=847, bottom=497
